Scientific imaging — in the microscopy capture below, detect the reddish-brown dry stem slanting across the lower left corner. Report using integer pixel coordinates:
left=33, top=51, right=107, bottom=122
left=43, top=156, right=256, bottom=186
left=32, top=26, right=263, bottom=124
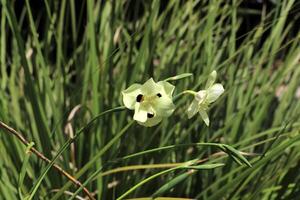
left=0, top=121, right=94, bottom=199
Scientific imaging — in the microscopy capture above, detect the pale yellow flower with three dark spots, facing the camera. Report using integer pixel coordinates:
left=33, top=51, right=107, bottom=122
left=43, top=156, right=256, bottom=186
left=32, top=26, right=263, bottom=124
left=122, top=78, right=175, bottom=127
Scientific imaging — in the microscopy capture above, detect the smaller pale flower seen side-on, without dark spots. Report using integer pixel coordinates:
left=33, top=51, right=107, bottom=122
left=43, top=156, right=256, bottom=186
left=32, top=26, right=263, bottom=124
left=187, top=71, right=224, bottom=126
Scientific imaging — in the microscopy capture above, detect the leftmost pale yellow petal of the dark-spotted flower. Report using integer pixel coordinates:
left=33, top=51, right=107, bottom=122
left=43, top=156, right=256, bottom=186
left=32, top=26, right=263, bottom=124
left=122, top=84, right=142, bottom=110
